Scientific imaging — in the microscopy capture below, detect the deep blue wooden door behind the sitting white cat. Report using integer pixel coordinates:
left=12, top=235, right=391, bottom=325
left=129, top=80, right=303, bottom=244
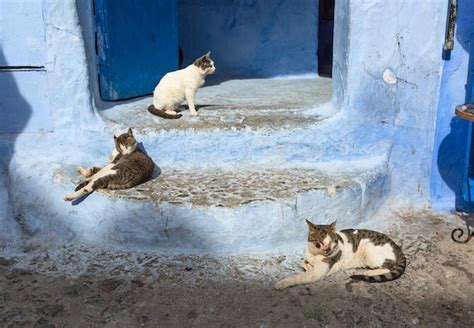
left=94, top=0, right=178, bottom=100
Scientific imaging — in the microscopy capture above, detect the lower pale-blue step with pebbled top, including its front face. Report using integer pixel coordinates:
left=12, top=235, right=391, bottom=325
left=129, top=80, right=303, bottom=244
left=11, top=157, right=388, bottom=254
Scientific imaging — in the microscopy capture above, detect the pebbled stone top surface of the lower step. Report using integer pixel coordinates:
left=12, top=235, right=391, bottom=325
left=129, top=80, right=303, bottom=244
left=96, top=168, right=356, bottom=207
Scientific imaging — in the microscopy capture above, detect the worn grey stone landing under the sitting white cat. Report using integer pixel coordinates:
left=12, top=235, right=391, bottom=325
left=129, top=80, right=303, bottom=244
left=101, top=78, right=332, bottom=131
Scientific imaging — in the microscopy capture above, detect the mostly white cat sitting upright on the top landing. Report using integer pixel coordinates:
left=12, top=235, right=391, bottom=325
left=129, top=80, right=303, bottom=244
left=148, top=51, right=216, bottom=118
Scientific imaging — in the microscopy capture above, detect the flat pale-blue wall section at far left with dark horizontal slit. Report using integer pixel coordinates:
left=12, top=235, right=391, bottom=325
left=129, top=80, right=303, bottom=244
left=0, top=0, right=53, bottom=134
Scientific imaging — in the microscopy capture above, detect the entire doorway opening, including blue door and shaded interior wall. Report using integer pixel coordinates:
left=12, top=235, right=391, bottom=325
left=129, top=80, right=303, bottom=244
left=93, top=0, right=334, bottom=101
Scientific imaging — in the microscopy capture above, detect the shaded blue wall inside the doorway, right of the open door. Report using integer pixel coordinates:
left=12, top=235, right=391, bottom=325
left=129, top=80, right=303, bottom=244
left=178, top=0, right=318, bottom=79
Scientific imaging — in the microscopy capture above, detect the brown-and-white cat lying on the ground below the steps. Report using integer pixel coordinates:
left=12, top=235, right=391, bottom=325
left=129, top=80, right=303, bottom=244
left=275, top=220, right=406, bottom=289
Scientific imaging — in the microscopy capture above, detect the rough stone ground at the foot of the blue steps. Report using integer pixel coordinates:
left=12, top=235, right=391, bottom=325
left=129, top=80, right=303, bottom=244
left=0, top=209, right=474, bottom=327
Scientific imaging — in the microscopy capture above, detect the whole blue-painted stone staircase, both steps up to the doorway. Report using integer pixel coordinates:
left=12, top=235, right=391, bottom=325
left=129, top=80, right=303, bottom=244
left=4, top=79, right=390, bottom=254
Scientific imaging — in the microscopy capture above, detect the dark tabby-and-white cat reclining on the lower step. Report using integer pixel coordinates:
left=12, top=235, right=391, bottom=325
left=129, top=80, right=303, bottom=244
left=64, top=128, right=155, bottom=201
